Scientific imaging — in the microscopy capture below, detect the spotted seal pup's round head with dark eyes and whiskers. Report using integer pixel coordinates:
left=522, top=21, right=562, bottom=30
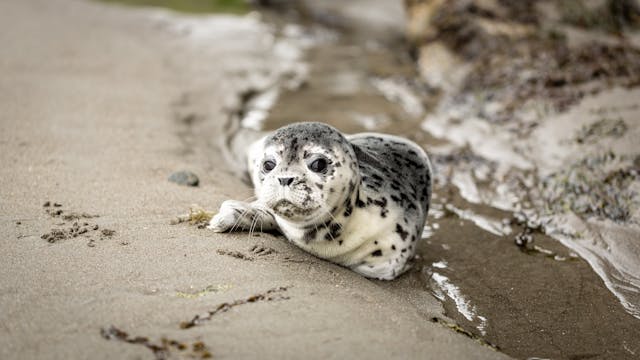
left=252, top=123, right=359, bottom=227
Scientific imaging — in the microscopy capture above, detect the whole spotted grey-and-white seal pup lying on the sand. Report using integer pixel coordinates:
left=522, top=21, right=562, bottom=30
left=209, top=123, right=432, bottom=280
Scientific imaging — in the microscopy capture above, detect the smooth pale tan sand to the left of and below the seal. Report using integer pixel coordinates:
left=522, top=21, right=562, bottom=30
left=0, top=0, right=504, bottom=359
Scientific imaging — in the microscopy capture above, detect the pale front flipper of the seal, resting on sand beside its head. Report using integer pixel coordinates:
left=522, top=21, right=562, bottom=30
left=207, top=200, right=278, bottom=232
